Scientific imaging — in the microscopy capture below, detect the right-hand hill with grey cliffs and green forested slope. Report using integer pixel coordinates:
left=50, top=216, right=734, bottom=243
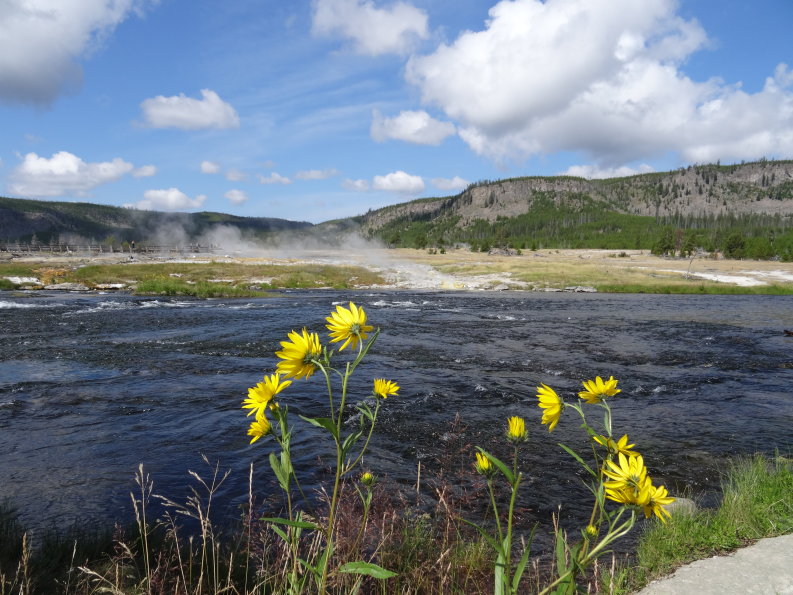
left=362, top=160, right=793, bottom=259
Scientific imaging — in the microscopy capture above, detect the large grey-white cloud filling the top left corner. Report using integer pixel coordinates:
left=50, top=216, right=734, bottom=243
left=0, top=0, right=148, bottom=106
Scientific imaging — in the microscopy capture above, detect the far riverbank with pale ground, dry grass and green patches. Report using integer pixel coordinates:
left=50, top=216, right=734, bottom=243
left=0, top=248, right=793, bottom=297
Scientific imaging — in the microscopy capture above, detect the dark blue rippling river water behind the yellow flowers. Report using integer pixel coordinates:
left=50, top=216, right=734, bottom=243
left=0, top=291, right=793, bottom=548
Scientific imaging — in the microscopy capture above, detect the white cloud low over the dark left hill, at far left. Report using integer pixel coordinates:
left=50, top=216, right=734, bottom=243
left=8, top=151, right=134, bottom=197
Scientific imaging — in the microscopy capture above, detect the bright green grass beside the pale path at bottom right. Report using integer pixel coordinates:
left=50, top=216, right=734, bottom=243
left=614, top=455, right=793, bottom=593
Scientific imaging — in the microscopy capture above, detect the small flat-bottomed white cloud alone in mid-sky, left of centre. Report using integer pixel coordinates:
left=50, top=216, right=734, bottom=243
left=140, top=89, right=240, bottom=130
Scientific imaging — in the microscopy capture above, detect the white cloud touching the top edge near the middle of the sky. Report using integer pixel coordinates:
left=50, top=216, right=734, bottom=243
left=312, top=0, right=429, bottom=56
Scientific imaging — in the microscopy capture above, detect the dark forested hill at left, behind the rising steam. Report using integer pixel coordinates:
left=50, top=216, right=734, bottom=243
left=0, top=197, right=312, bottom=244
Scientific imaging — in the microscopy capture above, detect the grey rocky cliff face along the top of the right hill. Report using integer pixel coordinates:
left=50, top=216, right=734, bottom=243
left=362, top=161, right=793, bottom=231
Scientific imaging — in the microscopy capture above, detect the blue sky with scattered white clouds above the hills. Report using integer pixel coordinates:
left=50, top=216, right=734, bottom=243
left=0, top=0, right=793, bottom=223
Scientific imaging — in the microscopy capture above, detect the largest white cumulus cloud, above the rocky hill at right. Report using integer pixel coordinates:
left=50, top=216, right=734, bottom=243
left=406, top=0, right=793, bottom=167
